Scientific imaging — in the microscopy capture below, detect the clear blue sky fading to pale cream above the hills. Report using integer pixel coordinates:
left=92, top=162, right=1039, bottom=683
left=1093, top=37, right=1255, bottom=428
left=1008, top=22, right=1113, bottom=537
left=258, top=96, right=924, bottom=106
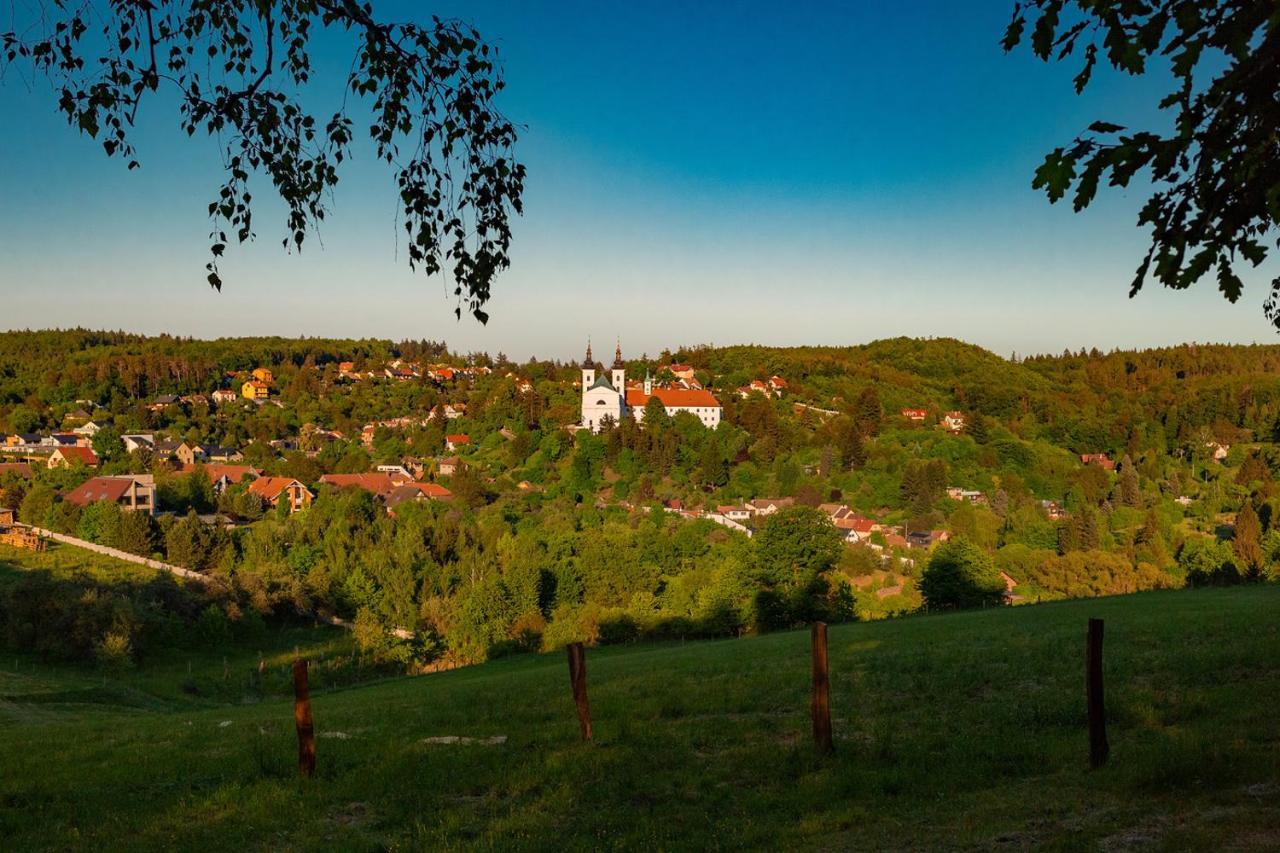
left=0, top=0, right=1275, bottom=359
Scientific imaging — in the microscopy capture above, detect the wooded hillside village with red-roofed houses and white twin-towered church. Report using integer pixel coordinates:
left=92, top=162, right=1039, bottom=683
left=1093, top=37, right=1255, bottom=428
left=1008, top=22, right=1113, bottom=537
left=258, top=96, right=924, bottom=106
left=0, top=333, right=1280, bottom=660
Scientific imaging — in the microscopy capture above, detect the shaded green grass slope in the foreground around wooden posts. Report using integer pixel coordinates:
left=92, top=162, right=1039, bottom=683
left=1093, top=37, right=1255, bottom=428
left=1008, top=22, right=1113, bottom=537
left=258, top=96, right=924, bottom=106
left=0, top=545, right=1280, bottom=850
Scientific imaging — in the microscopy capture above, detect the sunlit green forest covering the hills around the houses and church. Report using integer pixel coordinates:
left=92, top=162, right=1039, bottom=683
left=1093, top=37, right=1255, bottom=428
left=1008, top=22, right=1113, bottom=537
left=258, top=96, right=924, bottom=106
left=0, top=330, right=1280, bottom=665
